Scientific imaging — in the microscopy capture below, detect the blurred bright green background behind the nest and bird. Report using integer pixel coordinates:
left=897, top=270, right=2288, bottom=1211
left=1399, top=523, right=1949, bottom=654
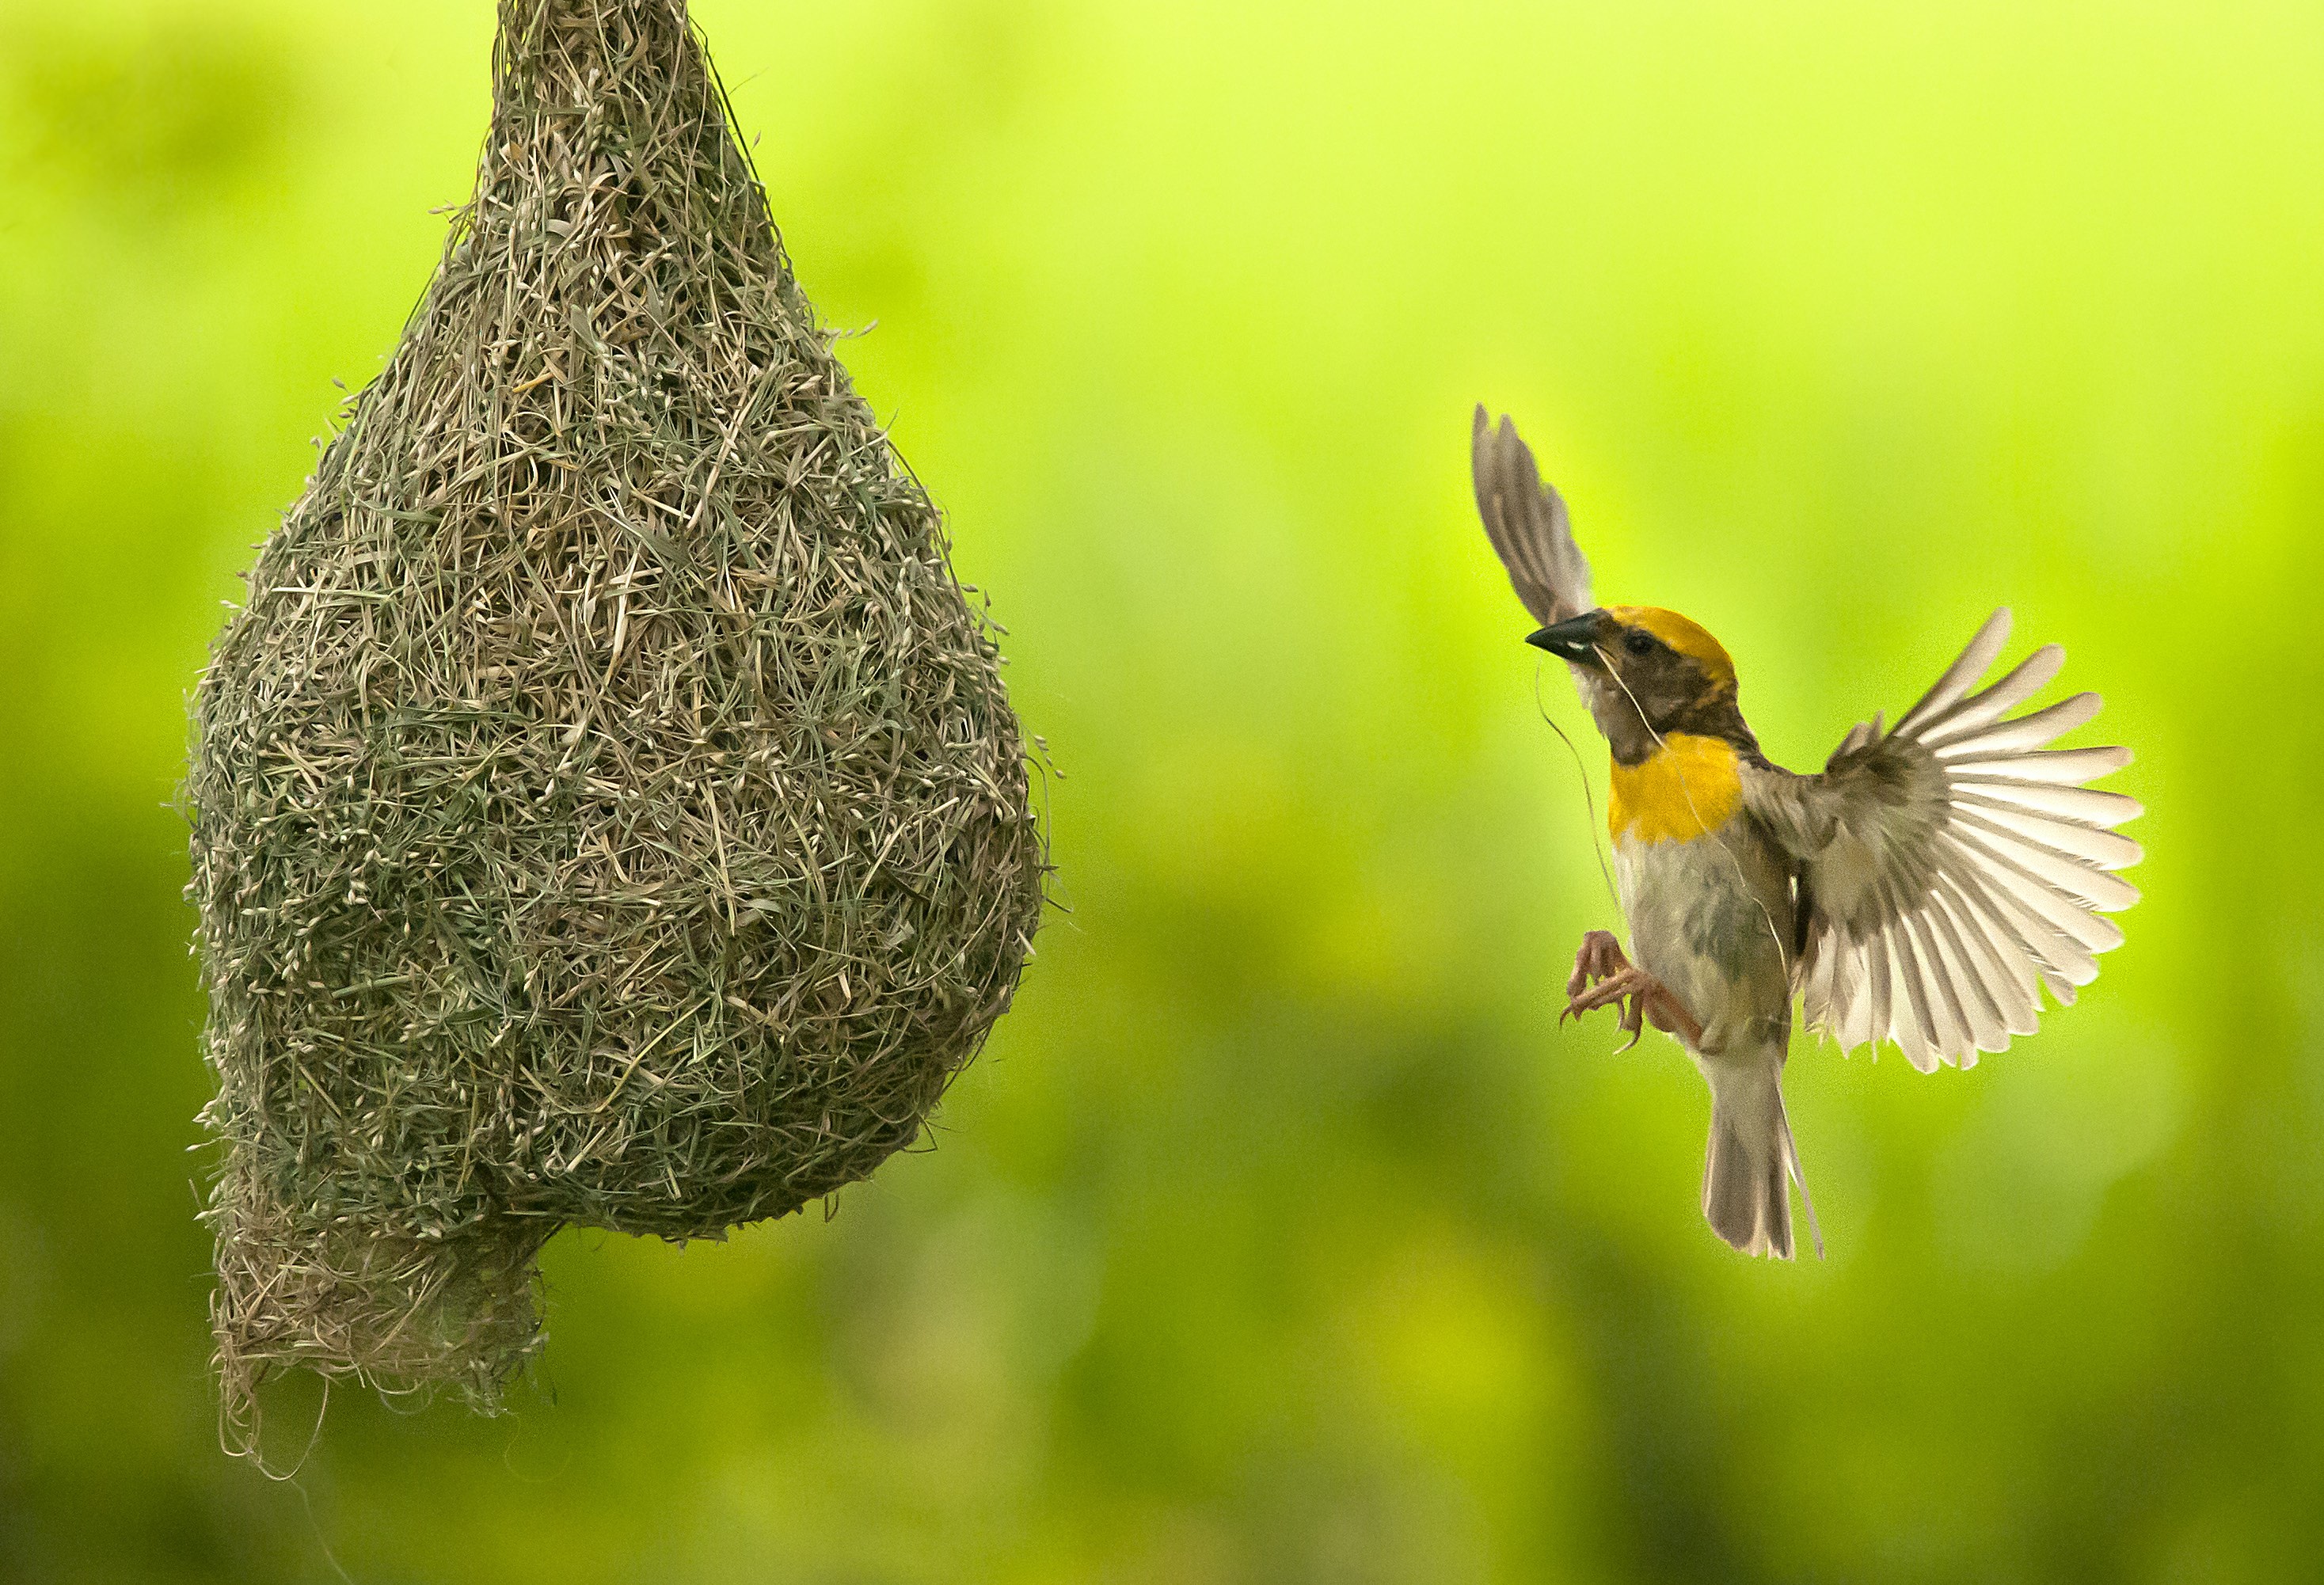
left=0, top=0, right=2324, bottom=1585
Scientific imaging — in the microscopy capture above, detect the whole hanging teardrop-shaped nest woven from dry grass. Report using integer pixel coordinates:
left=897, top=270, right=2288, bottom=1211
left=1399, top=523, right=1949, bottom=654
left=186, top=0, right=1044, bottom=1434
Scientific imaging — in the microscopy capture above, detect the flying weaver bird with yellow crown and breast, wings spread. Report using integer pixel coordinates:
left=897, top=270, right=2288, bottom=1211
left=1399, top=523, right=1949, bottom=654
left=1474, top=407, right=2140, bottom=1257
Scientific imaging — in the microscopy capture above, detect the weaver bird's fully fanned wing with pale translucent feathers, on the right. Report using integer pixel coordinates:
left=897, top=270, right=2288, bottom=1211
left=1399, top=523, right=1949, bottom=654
left=1743, top=609, right=2143, bottom=1071
